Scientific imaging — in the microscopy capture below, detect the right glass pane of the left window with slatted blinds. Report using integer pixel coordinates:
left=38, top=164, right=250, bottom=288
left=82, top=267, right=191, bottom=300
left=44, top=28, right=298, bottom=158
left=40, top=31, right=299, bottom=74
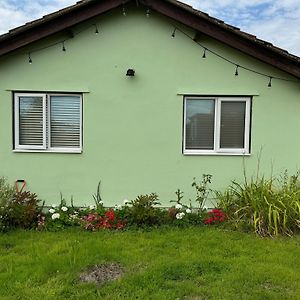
left=50, top=96, right=81, bottom=148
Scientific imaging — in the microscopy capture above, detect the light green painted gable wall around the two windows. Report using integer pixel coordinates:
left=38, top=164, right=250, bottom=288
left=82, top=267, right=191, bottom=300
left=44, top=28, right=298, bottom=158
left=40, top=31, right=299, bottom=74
left=0, top=7, right=300, bottom=205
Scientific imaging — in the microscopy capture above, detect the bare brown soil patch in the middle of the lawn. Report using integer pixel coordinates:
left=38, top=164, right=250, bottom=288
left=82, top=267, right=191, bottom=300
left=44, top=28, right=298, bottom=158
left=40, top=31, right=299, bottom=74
left=80, top=263, right=123, bottom=285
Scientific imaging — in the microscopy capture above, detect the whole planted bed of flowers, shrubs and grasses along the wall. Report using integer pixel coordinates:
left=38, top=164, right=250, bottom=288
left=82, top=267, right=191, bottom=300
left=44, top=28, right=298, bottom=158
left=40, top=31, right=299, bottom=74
left=0, top=172, right=300, bottom=236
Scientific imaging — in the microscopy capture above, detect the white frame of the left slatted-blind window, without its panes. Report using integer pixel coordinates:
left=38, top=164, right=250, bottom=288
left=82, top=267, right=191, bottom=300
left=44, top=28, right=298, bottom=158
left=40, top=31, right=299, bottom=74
left=14, top=93, right=83, bottom=153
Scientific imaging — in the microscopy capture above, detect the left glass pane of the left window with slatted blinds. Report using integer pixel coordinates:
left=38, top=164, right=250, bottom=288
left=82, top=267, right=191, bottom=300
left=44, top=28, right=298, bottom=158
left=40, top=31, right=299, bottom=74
left=19, top=96, right=43, bottom=146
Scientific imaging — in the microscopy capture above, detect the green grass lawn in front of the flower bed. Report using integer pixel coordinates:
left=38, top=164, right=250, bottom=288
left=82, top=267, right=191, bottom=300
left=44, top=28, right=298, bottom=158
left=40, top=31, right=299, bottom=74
left=0, top=227, right=300, bottom=300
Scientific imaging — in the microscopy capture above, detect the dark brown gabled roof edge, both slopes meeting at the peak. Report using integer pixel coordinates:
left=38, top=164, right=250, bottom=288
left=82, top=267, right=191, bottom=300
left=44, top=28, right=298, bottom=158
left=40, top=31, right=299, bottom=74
left=0, top=0, right=300, bottom=78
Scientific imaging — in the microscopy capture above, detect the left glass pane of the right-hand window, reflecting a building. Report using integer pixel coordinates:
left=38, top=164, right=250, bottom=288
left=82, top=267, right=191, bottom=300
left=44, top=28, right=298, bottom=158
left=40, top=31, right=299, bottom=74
left=185, top=99, right=215, bottom=150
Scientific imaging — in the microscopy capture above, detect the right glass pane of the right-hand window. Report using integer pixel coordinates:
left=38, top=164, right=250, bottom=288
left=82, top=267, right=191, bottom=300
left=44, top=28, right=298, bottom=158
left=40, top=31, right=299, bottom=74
left=220, top=101, right=246, bottom=149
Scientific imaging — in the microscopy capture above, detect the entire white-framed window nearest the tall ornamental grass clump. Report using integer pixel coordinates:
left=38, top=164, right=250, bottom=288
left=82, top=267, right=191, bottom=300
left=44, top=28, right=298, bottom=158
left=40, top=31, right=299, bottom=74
left=183, top=97, right=251, bottom=154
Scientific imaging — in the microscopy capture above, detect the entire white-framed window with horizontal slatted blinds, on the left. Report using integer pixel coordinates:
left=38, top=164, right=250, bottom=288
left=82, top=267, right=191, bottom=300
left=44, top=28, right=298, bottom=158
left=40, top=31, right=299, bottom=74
left=14, top=93, right=82, bottom=152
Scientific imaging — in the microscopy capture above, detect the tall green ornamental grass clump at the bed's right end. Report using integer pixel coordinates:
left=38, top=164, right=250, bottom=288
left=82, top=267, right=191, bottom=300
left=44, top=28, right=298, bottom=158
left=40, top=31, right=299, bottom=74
left=217, top=172, right=300, bottom=236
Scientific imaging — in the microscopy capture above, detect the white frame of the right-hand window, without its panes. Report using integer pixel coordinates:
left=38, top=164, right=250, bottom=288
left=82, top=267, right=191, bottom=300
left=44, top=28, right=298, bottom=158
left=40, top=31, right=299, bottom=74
left=183, top=96, right=251, bottom=155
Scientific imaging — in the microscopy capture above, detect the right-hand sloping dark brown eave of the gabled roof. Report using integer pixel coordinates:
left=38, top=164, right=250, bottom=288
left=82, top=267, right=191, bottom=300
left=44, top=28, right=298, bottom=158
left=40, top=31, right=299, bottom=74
left=140, top=0, right=300, bottom=78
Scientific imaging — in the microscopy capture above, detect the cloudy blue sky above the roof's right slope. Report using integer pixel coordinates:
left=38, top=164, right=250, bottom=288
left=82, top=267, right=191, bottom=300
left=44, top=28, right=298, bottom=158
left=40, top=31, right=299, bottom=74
left=185, top=0, right=300, bottom=55
